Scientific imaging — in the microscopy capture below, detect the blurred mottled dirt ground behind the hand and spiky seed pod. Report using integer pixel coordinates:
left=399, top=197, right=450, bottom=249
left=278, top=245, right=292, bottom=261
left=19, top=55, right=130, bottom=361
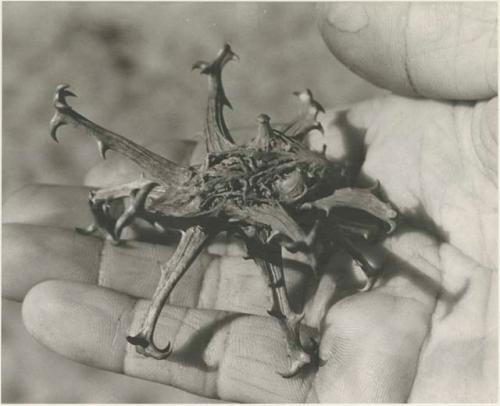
left=2, top=2, right=383, bottom=403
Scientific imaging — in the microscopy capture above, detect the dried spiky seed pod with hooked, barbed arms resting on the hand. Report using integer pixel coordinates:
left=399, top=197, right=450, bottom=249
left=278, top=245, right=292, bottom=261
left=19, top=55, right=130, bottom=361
left=50, top=44, right=397, bottom=377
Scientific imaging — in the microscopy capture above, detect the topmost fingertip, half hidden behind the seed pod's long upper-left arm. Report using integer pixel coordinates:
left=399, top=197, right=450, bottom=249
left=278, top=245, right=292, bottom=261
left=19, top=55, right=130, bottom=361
left=84, top=139, right=197, bottom=187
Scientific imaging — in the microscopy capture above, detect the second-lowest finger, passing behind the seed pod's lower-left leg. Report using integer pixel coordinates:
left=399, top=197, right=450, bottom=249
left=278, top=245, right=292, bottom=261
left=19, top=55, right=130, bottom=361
left=2, top=224, right=308, bottom=315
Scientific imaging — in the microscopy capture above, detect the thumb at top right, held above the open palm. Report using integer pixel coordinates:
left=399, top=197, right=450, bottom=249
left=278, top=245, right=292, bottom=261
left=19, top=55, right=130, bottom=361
left=318, top=2, right=497, bottom=100
